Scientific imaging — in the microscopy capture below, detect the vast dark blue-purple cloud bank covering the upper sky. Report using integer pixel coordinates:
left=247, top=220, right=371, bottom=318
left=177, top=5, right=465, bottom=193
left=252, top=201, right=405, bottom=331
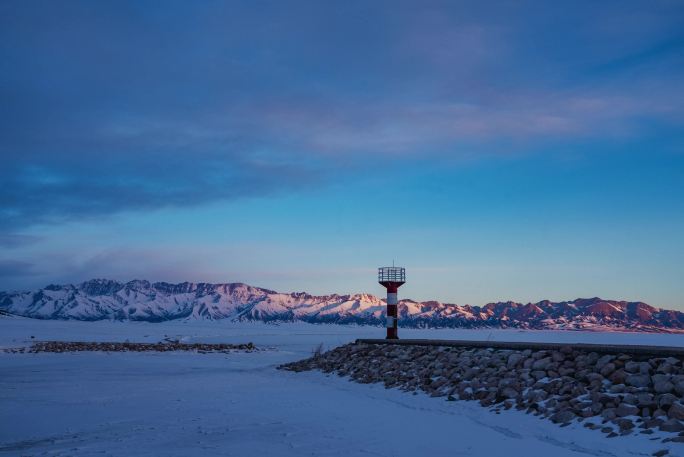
left=0, top=1, right=684, bottom=228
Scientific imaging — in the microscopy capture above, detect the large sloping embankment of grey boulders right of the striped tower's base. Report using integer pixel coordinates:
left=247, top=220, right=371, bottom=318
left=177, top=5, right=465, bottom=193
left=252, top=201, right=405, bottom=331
left=279, top=343, right=684, bottom=442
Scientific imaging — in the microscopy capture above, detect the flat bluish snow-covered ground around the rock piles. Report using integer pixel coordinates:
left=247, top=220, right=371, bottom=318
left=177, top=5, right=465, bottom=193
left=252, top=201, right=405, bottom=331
left=0, top=318, right=684, bottom=457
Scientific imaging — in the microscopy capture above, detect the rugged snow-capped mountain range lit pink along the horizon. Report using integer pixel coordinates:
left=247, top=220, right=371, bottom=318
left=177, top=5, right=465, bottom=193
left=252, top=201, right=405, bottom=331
left=0, top=279, right=684, bottom=331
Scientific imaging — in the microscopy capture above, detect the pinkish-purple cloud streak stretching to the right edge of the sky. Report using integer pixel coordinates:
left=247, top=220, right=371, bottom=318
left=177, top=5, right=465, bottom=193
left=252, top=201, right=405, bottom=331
left=254, top=92, right=684, bottom=153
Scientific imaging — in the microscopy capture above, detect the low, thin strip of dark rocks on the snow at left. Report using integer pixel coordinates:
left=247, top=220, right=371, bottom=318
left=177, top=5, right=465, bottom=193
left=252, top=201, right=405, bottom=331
left=5, top=341, right=256, bottom=353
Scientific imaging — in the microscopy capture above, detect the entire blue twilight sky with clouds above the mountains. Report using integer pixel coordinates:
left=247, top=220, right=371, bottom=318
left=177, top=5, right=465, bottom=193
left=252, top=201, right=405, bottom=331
left=0, top=0, right=684, bottom=310
